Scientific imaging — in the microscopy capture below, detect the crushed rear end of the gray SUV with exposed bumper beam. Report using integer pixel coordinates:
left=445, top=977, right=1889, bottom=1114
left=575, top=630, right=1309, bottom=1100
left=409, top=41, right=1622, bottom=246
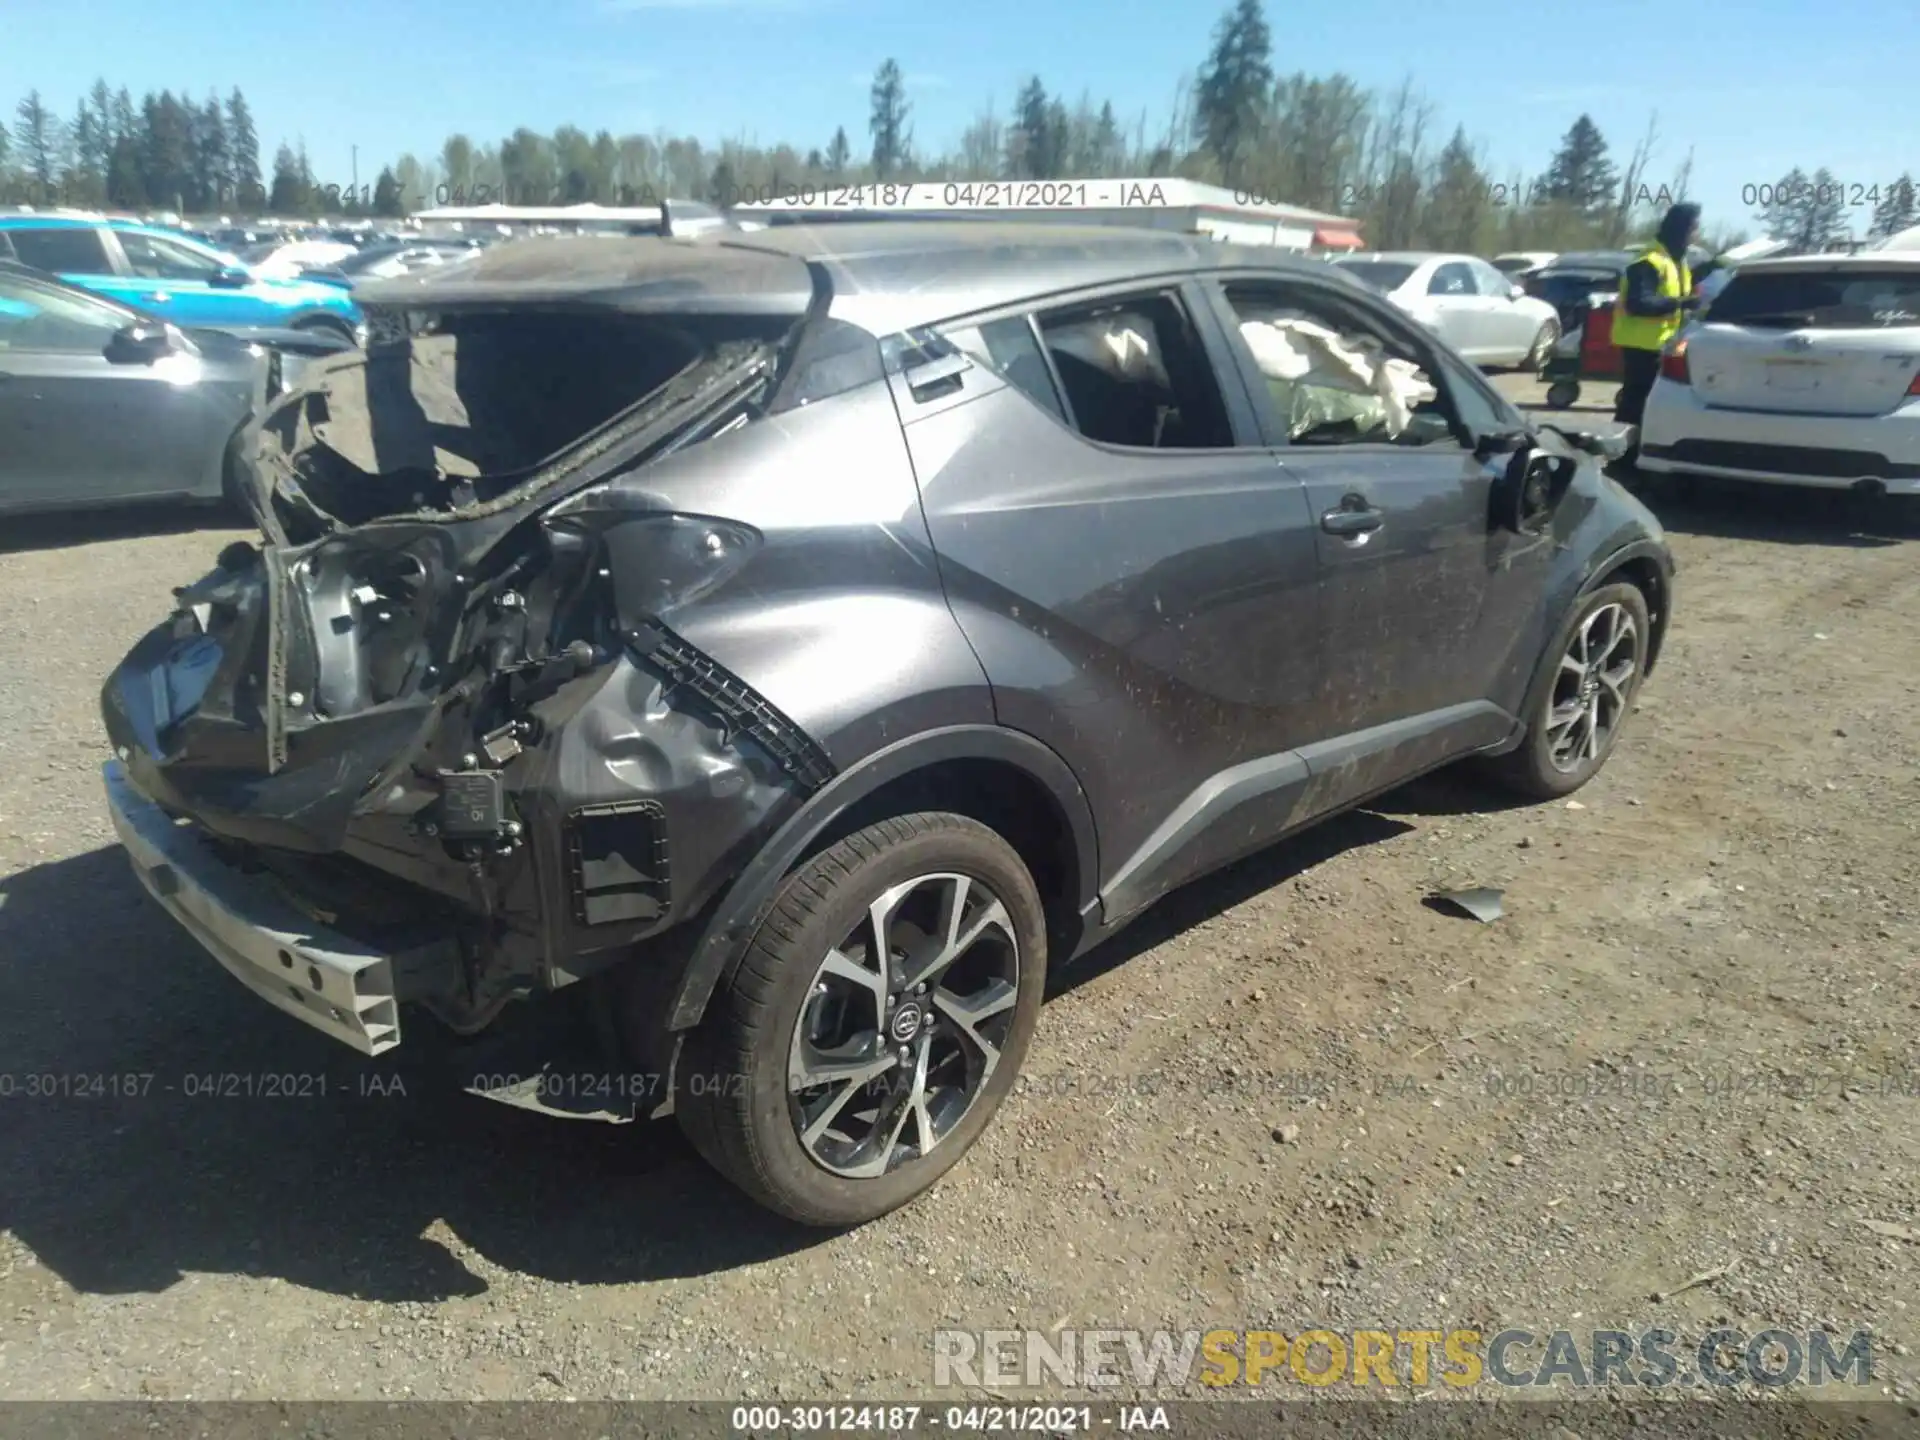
left=102, top=240, right=829, bottom=1090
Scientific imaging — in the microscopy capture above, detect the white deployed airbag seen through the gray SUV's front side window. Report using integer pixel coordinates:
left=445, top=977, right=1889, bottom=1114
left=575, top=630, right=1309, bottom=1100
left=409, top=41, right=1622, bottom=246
left=1240, top=321, right=1438, bottom=438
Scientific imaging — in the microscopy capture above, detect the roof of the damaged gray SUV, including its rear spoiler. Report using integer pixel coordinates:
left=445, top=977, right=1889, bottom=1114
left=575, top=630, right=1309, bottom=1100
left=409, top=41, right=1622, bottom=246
left=357, top=221, right=1348, bottom=334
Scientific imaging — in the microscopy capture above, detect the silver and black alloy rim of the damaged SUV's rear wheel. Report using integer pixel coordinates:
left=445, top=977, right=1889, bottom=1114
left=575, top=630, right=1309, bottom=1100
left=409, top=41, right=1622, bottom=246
left=787, top=874, right=1021, bottom=1179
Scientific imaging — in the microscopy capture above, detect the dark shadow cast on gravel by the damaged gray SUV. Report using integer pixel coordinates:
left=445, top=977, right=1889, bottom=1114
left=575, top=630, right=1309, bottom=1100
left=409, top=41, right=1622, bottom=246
left=0, top=810, right=1443, bottom=1302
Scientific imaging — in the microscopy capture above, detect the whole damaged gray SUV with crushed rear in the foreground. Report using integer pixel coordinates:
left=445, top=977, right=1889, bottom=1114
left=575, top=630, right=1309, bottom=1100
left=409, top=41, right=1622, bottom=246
left=102, top=223, right=1672, bottom=1225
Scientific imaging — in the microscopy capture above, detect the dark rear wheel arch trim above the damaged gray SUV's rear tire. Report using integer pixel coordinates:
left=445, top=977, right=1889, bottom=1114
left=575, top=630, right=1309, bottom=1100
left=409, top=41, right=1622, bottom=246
left=666, top=726, right=1100, bottom=1031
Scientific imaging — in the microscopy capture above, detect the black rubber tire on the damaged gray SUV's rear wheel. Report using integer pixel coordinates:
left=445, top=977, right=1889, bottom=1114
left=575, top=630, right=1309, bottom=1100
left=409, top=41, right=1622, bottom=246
left=674, top=812, right=1046, bottom=1227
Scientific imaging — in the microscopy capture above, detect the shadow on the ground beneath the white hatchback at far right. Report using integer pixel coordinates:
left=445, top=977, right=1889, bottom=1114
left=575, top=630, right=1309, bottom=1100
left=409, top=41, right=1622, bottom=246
left=1615, top=468, right=1920, bottom=549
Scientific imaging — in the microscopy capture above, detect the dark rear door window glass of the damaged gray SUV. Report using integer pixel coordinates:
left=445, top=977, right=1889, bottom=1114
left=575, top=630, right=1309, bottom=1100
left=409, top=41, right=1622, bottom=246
left=1037, top=294, right=1235, bottom=449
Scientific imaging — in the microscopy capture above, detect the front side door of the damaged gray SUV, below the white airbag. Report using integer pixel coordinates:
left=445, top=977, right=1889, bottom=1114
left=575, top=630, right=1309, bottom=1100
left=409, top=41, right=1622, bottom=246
left=1212, top=275, right=1551, bottom=810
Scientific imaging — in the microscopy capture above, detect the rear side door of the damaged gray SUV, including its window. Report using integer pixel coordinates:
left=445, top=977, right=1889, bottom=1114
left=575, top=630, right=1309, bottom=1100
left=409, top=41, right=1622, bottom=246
left=891, top=280, right=1319, bottom=920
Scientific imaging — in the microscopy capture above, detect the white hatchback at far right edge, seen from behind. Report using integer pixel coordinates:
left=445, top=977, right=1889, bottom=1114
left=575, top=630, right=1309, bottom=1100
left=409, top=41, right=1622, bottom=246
left=1640, top=250, right=1920, bottom=495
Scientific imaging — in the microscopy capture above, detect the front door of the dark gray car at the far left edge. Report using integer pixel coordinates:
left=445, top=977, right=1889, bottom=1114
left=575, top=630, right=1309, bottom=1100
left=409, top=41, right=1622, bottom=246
left=0, top=275, right=227, bottom=507
